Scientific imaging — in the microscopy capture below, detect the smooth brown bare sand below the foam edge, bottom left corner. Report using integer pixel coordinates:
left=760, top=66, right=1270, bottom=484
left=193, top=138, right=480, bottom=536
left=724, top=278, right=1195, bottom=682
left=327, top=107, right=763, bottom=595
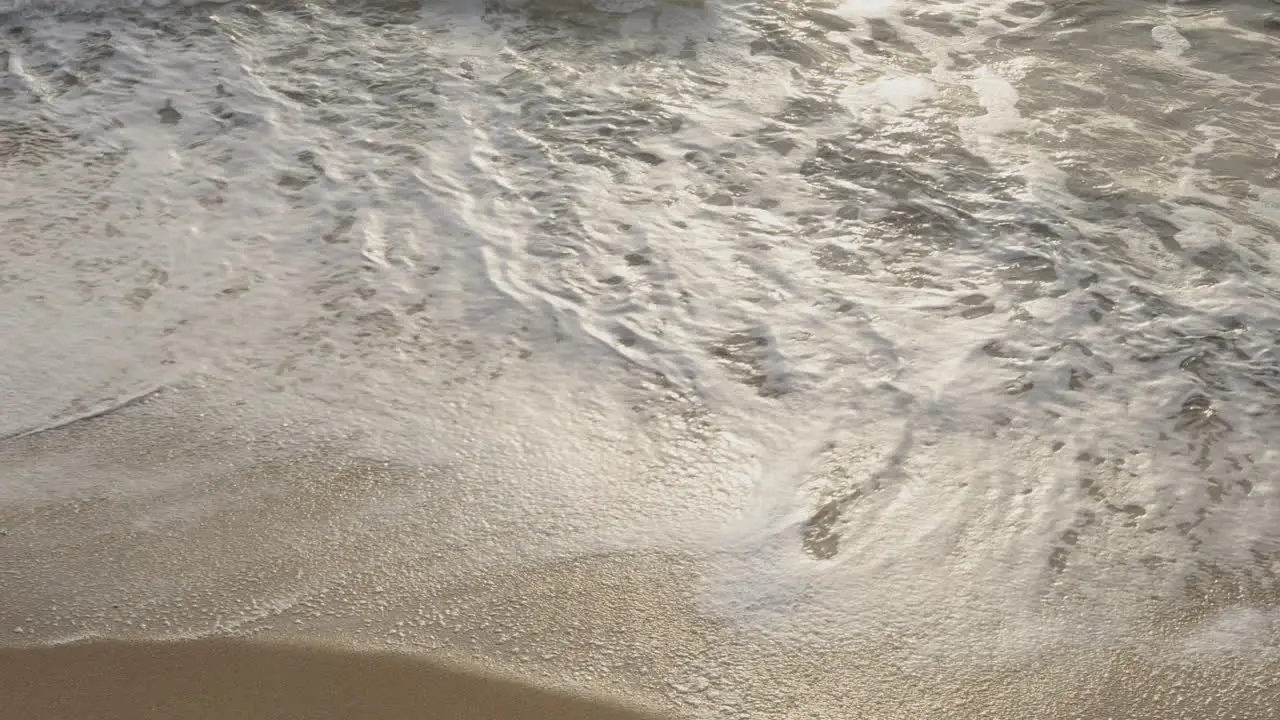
left=0, top=638, right=675, bottom=720
